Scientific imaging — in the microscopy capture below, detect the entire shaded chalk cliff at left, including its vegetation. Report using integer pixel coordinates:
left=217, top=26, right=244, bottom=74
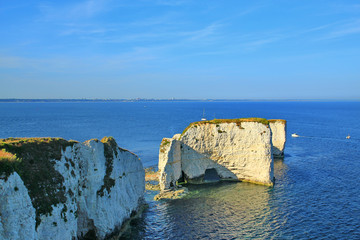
left=0, top=138, right=145, bottom=239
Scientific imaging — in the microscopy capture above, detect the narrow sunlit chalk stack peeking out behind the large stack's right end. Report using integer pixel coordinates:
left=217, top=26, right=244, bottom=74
left=269, top=119, right=286, bottom=158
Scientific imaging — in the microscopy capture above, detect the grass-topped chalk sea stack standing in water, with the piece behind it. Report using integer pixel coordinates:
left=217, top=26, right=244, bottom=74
left=159, top=118, right=285, bottom=191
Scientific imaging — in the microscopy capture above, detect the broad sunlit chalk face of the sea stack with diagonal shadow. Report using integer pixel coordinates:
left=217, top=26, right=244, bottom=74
left=181, top=122, right=273, bottom=185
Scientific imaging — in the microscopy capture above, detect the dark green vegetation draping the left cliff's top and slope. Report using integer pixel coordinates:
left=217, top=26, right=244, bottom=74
left=0, top=138, right=76, bottom=228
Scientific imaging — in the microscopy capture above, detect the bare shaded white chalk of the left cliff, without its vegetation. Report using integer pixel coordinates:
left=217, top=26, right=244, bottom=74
left=0, top=139, right=145, bottom=239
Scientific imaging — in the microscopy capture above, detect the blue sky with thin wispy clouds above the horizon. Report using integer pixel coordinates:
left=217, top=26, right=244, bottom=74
left=0, top=0, right=360, bottom=100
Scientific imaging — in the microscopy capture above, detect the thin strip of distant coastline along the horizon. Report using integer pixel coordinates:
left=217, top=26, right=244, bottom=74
left=0, top=98, right=360, bottom=103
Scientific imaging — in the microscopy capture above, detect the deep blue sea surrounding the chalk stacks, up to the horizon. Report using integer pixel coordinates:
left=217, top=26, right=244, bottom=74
left=0, top=101, right=360, bottom=239
